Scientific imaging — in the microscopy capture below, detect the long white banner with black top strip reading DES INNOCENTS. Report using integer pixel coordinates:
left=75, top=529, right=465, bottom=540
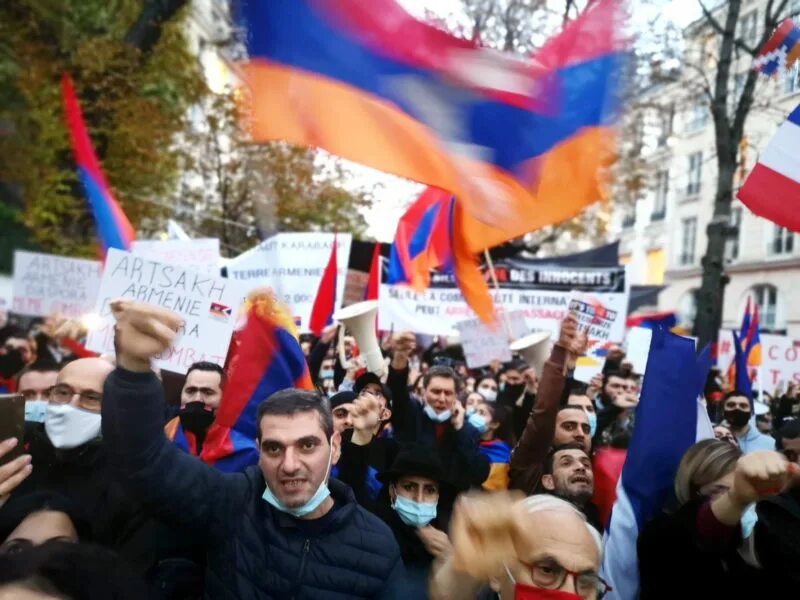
left=378, top=261, right=628, bottom=342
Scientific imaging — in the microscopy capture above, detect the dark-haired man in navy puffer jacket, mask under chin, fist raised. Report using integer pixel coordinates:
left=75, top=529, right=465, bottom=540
left=103, top=300, right=403, bottom=599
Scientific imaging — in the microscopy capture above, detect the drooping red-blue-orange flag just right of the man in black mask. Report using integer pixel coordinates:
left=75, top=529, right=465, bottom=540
left=200, top=295, right=313, bottom=472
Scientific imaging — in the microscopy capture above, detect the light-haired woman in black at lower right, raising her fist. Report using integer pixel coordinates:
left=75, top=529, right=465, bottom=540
left=637, top=439, right=790, bottom=600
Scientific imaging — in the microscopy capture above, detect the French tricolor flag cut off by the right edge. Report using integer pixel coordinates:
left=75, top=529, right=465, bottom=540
left=737, top=106, right=800, bottom=231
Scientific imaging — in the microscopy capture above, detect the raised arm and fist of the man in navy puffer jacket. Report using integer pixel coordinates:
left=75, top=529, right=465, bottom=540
left=102, top=301, right=247, bottom=538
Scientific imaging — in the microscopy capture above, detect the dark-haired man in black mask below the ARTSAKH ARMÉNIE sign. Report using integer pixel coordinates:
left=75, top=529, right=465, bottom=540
left=164, top=361, right=225, bottom=456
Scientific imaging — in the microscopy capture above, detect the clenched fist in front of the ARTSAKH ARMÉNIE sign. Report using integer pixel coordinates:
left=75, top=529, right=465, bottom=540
left=111, top=299, right=182, bottom=373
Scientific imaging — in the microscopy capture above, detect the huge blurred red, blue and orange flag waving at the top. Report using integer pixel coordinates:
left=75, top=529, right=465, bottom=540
left=243, top=0, right=622, bottom=320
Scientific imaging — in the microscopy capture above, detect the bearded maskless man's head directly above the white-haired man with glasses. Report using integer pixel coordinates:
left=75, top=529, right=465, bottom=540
left=540, top=443, right=602, bottom=530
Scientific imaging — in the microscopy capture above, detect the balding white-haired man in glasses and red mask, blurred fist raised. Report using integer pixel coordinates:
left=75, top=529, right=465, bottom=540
left=430, top=493, right=608, bottom=600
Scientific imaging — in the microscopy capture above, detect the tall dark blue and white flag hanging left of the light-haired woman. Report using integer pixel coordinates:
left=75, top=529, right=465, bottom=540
left=602, top=329, right=714, bottom=600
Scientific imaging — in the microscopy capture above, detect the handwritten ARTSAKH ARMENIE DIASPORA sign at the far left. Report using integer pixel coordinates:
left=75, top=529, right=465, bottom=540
left=12, top=250, right=100, bottom=319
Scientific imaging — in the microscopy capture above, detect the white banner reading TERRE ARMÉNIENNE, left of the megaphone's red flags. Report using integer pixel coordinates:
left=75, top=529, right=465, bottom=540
left=226, top=233, right=352, bottom=332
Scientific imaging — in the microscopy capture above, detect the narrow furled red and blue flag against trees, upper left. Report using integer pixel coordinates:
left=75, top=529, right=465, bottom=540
left=61, top=73, right=136, bottom=256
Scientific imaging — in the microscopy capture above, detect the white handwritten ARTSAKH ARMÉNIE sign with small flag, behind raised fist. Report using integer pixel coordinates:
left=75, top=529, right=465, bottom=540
left=86, top=248, right=244, bottom=373
